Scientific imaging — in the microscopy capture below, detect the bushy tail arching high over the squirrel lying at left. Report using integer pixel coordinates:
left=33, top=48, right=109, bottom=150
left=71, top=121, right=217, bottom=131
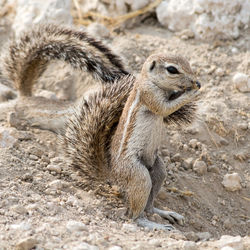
left=3, top=24, right=128, bottom=96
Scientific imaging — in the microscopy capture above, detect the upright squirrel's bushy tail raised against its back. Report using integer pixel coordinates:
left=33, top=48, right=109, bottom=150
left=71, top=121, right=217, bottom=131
left=62, top=76, right=135, bottom=181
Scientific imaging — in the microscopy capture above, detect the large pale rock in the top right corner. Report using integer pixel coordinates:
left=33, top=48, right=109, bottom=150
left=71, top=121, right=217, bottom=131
left=156, top=0, right=250, bottom=39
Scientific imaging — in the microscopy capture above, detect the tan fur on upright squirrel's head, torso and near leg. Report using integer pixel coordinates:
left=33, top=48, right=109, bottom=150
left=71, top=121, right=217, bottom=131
left=111, top=55, right=198, bottom=219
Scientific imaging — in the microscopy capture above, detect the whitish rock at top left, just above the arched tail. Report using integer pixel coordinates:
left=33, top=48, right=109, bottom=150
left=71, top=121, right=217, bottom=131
left=13, top=0, right=72, bottom=36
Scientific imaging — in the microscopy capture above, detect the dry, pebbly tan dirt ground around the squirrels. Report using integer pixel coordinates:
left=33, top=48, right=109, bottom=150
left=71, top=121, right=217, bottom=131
left=0, top=8, right=250, bottom=250
